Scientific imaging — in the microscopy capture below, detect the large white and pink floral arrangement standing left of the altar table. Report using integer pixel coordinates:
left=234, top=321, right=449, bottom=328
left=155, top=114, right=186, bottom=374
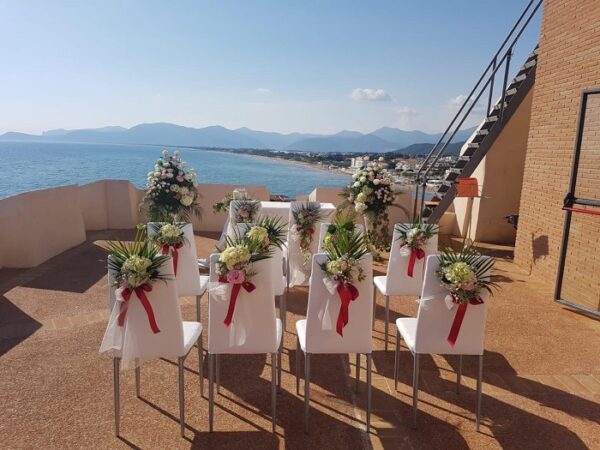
left=142, top=150, right=201, bottom=222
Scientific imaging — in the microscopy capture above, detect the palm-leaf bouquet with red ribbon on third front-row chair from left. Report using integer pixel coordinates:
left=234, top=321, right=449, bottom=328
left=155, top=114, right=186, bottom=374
left=320, top=231, right=368, bottom=336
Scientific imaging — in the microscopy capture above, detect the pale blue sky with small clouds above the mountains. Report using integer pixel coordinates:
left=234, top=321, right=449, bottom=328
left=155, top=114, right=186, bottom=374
left=0, top=0, right=540, bottom=134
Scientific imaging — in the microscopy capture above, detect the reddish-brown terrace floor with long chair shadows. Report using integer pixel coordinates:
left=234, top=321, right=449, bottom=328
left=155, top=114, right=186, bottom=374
left=0, top=231, right=600, bottom=450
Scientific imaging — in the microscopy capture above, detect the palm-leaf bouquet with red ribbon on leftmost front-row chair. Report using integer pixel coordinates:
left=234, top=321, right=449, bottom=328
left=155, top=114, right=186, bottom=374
left=106, top=225, right=170, bottom=333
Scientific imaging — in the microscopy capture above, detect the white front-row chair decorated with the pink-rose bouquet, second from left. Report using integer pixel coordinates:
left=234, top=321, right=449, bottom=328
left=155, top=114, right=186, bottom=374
left=208, top=254, right=282, bottom=431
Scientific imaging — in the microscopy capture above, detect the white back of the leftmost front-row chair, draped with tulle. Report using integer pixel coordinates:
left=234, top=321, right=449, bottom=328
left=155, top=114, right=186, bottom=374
left=101, top=260, right=184, bottom=368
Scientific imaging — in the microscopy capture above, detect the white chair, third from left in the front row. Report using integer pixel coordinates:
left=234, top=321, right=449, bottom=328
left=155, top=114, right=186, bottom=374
left=296, top=253, right=373, bottom=432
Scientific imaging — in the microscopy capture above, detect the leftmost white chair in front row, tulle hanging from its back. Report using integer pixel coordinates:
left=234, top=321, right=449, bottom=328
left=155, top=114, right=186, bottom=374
left=101, top=261, right=203, bottom=436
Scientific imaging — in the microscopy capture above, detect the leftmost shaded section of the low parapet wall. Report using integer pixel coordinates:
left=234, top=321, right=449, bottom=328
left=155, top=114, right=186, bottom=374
left=0, top=186, right=85, bottom=268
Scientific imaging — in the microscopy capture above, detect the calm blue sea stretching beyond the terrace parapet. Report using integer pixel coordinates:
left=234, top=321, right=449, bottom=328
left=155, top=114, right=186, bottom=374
left=0, top=141, right=350, bottom=198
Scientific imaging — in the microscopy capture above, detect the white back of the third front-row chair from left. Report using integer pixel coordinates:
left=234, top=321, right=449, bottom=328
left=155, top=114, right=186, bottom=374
left=306, top=253, right=373, bottom=353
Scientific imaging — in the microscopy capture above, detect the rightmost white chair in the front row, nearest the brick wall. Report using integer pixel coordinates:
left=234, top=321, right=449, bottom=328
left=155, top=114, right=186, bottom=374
left=394, top=255, right=490, bottom=431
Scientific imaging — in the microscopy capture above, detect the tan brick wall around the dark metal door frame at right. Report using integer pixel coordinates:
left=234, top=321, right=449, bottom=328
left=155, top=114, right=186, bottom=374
left=515, top=0, right=600, bottom=309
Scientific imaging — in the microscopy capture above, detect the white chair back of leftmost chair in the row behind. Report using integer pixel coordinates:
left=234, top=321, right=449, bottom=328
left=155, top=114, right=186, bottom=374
left=147, top=222, right=202, bottom=297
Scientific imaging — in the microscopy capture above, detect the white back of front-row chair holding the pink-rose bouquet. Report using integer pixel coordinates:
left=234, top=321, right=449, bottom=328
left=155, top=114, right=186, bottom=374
left=208, top=253, right=279, bottom=354
